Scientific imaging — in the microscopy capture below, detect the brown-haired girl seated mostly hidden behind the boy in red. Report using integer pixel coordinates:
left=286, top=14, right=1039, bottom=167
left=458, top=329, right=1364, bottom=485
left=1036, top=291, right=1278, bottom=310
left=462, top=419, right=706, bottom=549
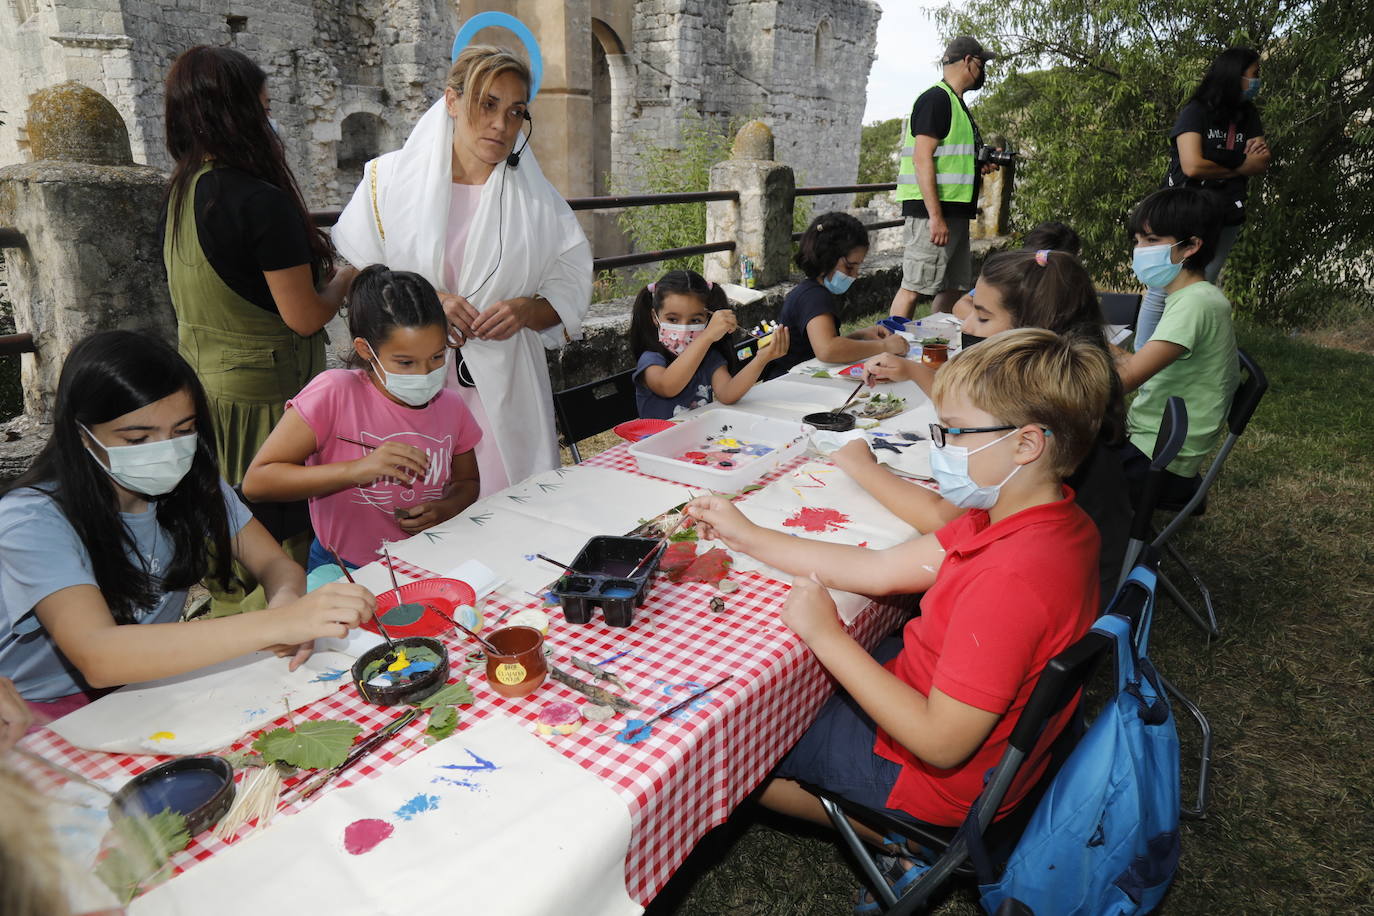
left=831, top=249, right=1131, bottom=602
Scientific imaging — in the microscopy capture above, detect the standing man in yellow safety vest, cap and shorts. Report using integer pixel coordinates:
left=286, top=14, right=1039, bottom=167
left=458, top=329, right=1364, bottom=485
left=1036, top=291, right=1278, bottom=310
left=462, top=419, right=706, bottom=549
left=892, top=36, right=998, bottom=317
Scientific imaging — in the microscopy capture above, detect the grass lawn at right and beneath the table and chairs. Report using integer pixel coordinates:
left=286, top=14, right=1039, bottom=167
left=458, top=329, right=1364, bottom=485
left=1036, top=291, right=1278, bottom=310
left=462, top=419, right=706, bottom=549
left=623, top=318, right=1374, bottom=916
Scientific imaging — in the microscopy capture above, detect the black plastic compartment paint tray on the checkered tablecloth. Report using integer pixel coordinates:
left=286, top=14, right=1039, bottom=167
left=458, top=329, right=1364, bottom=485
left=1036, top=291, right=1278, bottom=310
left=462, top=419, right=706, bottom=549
left=554, top=537, right=664, bottom=626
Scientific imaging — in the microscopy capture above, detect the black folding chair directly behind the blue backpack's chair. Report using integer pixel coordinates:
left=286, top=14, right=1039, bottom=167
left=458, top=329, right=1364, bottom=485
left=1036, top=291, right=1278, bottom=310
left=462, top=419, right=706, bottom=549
left=1117, top=397, right=1212, bottom=817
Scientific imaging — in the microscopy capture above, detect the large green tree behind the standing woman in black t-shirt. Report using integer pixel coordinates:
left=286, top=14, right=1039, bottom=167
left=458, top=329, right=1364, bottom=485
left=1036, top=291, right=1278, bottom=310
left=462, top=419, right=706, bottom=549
left=940, top=0, right=1374, bottom=324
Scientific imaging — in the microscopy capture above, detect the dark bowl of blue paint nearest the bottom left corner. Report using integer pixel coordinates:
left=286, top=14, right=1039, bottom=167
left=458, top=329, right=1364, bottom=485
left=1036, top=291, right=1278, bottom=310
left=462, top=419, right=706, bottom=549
left=110, top=757, right=234, bottom=836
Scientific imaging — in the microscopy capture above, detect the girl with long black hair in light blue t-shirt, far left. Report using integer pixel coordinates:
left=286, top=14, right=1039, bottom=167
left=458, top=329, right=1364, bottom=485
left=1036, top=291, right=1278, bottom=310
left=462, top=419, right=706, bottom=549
left=0, top=331, right=376, bottom=721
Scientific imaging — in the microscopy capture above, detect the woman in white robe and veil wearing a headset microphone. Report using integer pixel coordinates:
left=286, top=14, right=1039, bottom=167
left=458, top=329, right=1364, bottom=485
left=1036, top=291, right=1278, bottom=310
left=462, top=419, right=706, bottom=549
left=334, top=45, right=592, bottom=496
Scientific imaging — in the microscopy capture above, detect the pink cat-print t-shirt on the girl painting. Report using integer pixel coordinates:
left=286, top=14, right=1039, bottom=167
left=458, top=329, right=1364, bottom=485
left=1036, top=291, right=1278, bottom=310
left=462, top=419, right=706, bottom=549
left=286, top=369, right=482, bottom=566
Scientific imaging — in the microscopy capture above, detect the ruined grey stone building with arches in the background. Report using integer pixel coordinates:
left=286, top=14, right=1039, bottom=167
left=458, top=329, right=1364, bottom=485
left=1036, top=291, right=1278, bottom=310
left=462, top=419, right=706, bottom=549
left=0, top=0, right=881, bottom=243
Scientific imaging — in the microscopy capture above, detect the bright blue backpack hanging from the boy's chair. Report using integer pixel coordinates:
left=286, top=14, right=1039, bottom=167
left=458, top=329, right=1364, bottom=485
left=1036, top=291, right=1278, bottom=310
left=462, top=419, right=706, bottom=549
left=980, top=567, right=1179, bottom=916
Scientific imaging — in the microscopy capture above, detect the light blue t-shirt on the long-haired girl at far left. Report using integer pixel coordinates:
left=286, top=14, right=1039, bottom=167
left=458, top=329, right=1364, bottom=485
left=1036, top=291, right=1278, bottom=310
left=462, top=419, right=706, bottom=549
left=0, top=481, right=253, bottom=702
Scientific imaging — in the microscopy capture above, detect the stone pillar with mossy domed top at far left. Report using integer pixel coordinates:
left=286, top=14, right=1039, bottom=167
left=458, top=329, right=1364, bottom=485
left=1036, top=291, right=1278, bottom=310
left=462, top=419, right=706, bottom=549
left=0, top=82, right=176, bottom=419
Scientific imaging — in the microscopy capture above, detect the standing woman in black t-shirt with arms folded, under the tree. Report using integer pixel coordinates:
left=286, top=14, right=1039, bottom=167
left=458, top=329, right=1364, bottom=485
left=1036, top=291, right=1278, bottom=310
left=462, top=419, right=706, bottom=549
left=1135, top=48, right=1270, bottom=349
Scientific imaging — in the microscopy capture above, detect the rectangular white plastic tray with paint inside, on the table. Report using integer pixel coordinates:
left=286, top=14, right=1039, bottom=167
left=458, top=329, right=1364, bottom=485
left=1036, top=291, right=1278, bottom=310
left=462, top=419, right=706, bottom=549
left=629, top=407, right=813, bottom=492
